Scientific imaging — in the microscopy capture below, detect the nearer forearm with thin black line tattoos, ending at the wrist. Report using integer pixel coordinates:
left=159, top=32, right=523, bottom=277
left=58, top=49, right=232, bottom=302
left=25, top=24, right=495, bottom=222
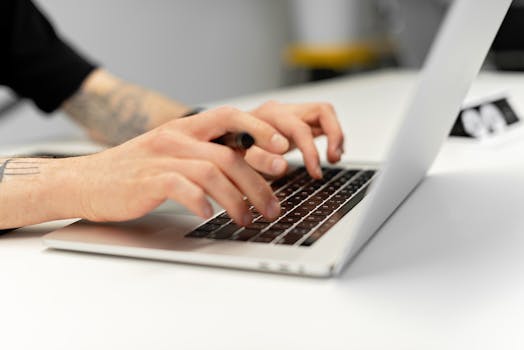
left=0, top=158, right=81, bottom=229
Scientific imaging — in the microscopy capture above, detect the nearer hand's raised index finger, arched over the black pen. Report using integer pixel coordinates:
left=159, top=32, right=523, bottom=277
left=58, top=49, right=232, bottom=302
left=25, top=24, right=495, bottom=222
left=180, top=107, right=289, bottom=153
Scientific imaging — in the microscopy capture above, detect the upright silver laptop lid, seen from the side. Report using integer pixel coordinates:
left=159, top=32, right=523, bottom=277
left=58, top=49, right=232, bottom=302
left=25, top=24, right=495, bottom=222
left=339, top=0, right=511, bottom=271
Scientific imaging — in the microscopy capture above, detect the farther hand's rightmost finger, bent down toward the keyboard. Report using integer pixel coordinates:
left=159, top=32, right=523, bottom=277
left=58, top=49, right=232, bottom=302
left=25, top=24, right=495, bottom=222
left=317, top=103, right=344, bottom=163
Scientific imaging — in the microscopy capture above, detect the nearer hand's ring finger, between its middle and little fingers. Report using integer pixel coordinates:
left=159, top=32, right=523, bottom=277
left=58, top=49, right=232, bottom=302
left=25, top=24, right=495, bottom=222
left=172, top=159, right=252, bottom=226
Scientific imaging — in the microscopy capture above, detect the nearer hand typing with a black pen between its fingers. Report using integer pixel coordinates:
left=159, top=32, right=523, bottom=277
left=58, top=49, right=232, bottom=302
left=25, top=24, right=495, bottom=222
left=70, top=107, right=289, bottom=226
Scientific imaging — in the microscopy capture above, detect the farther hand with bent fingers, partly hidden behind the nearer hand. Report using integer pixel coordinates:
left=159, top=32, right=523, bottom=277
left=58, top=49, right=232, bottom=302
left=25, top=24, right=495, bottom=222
left=246, top=101, right=344, bottom=178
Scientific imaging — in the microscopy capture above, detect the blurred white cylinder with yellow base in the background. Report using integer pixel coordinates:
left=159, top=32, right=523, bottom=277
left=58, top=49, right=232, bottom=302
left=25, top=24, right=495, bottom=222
left=284, top=0, right=391, bottom=75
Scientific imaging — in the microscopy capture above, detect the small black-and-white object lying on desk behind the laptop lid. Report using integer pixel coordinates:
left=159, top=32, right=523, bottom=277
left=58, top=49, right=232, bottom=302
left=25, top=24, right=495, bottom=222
left=450, top=98, right=520, bottom=139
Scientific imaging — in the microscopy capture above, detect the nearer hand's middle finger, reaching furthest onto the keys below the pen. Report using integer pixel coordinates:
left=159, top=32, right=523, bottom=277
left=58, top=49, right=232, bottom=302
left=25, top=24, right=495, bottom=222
left=177, top=142, right=280, bottom=219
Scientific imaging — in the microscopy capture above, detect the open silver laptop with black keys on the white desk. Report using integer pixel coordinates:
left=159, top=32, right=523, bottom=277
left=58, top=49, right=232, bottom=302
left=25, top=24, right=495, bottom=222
left=43, top=0, right=511, bottom=277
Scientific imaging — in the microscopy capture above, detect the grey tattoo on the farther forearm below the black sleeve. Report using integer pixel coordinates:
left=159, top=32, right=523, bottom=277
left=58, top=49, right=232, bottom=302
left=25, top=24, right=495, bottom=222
left=64, top=83, right=149, bottom=144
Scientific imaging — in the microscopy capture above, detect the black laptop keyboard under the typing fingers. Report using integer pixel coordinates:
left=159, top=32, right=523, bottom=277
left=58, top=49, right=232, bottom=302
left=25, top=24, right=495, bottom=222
left=186, top=167, right=375, bottom=247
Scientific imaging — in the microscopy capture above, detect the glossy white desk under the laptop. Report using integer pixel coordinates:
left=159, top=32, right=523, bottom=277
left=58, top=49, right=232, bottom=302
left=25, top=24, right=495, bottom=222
left=0, top=69, right=524, bottom=350
